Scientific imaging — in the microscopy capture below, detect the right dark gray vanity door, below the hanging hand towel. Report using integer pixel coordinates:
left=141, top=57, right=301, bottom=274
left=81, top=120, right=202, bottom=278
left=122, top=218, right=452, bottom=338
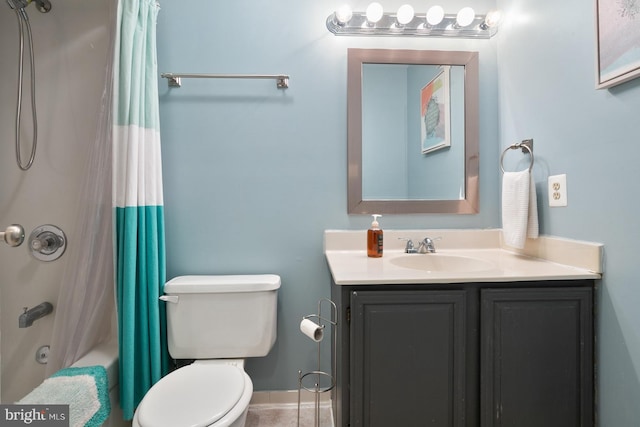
left=480, top=288, right=593, bottom=427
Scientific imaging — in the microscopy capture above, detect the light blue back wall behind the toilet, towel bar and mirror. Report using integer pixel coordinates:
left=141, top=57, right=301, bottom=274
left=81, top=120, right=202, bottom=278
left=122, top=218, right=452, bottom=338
left=158, top=0, right=499, bottom=390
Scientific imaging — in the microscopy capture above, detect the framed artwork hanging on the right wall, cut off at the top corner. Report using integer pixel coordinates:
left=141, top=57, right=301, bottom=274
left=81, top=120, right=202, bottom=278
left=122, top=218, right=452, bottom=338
left=595, top=0, right=640, bottom=89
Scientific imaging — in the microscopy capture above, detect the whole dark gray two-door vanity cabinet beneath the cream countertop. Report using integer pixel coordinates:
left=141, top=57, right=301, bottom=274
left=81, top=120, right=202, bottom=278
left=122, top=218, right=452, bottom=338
left=332, top=280, right=594, bottom=427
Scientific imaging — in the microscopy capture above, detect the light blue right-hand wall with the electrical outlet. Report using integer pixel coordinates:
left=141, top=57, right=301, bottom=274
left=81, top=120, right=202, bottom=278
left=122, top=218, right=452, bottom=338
left=497, top=0, right=640, bottom=427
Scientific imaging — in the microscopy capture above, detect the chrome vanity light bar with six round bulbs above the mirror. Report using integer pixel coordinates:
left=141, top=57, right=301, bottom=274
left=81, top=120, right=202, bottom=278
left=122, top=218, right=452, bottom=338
left=327, top=2, right=501, bottom=39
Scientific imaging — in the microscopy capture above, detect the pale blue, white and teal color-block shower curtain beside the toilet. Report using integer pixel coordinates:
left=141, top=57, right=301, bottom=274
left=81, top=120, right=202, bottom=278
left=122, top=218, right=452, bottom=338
left=113, top=0, right=169, bottom=419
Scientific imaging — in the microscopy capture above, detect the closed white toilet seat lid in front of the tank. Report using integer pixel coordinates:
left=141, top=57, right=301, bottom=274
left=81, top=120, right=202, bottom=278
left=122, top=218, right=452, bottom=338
left=136, top=363, right=246, bottom=427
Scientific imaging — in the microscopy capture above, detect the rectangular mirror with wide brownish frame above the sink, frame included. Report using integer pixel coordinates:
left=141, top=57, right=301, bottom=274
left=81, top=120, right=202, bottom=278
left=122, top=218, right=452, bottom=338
left=347, top=49, right=479, bottom=214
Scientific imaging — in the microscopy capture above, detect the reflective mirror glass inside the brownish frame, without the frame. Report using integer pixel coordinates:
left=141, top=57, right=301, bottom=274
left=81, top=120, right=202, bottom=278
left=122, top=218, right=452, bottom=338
left=362, top=64, right=465, bottom=200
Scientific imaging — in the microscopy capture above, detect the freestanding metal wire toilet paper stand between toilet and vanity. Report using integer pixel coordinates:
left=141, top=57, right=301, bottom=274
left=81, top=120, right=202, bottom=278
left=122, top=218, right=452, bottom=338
left=297, top=298, right=338, bottom=427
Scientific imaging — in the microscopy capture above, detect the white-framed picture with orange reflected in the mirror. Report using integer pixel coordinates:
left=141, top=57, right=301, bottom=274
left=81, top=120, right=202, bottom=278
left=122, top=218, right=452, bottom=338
left=420, top=65, right=451, bottom=154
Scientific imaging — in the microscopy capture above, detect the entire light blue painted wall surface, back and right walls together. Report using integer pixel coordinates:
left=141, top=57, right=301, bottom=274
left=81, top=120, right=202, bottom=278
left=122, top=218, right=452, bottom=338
left=158, top=0, right=640, bottom=427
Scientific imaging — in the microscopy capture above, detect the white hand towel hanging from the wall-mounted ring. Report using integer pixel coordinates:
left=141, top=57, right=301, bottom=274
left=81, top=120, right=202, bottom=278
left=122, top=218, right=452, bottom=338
left=502, top=170, right=538, bottom=249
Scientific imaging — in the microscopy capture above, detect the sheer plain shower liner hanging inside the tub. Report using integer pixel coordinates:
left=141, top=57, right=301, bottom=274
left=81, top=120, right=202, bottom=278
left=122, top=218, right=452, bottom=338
left=46, top=0, right=116, bottom=377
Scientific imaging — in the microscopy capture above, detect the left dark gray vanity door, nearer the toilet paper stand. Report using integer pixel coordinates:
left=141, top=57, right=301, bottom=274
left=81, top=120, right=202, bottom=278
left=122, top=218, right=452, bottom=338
left=350, top=290, right=470, bottom=427
